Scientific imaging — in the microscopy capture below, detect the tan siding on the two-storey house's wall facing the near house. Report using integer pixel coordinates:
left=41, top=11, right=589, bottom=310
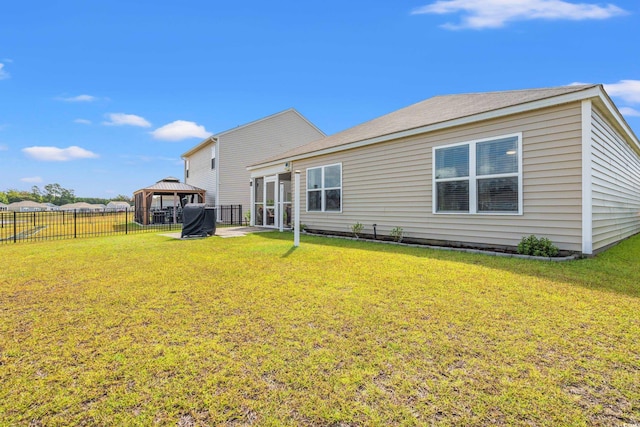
left=217, top=110, right=324, bottom=212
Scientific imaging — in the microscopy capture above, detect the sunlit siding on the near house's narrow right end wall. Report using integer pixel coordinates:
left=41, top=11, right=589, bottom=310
left=591, top=108, right=640, bottom=250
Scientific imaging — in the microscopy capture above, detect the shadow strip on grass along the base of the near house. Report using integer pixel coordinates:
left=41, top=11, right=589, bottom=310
left=256, top=232, right=640, bottom=298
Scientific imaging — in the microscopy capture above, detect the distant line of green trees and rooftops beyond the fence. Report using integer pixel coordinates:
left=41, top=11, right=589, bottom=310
left=0, top=183, right=131, bottom=206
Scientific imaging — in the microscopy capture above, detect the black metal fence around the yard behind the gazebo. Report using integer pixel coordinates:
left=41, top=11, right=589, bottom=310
left=0, top=205, right=244, bottom=244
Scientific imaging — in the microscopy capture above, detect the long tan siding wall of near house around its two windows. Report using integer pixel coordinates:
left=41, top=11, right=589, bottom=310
left=293, top=102, right=582, bottom=251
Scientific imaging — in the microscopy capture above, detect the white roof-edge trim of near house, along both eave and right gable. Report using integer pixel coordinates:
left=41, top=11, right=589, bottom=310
left=247, top=85, right=640, bottom=171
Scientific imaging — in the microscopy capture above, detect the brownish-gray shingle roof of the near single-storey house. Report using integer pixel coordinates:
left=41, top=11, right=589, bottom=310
left=252, top=85, right=598, bottom=166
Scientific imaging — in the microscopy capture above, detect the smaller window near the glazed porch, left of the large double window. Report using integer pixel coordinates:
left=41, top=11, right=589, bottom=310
left=307, top=164, right=342, bottom=212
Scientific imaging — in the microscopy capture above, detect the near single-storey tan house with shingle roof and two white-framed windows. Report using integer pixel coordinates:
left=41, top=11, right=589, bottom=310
left=248, top=85, right=640, bottom=254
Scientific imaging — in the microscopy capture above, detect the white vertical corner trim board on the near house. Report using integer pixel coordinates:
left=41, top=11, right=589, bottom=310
left=582, top=99, right=593, bottom=255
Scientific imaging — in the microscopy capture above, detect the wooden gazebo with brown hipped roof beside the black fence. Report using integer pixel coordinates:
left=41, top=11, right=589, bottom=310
left=133, top=176, right=206, bottom=225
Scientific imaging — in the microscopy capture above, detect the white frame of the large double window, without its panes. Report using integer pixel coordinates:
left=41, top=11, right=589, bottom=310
left=431, top=132, right=523, bottom=216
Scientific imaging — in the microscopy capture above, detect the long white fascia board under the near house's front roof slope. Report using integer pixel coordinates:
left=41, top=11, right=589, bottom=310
left=247, top=86, right=602, bottom=170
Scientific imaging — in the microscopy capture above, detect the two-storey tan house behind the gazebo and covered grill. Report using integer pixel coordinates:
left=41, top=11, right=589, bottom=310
left=182, top=109, right=325, bottom=212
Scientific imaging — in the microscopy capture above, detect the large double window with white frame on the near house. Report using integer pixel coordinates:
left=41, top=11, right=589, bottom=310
left=433, top=134, right=522, bottom=214
